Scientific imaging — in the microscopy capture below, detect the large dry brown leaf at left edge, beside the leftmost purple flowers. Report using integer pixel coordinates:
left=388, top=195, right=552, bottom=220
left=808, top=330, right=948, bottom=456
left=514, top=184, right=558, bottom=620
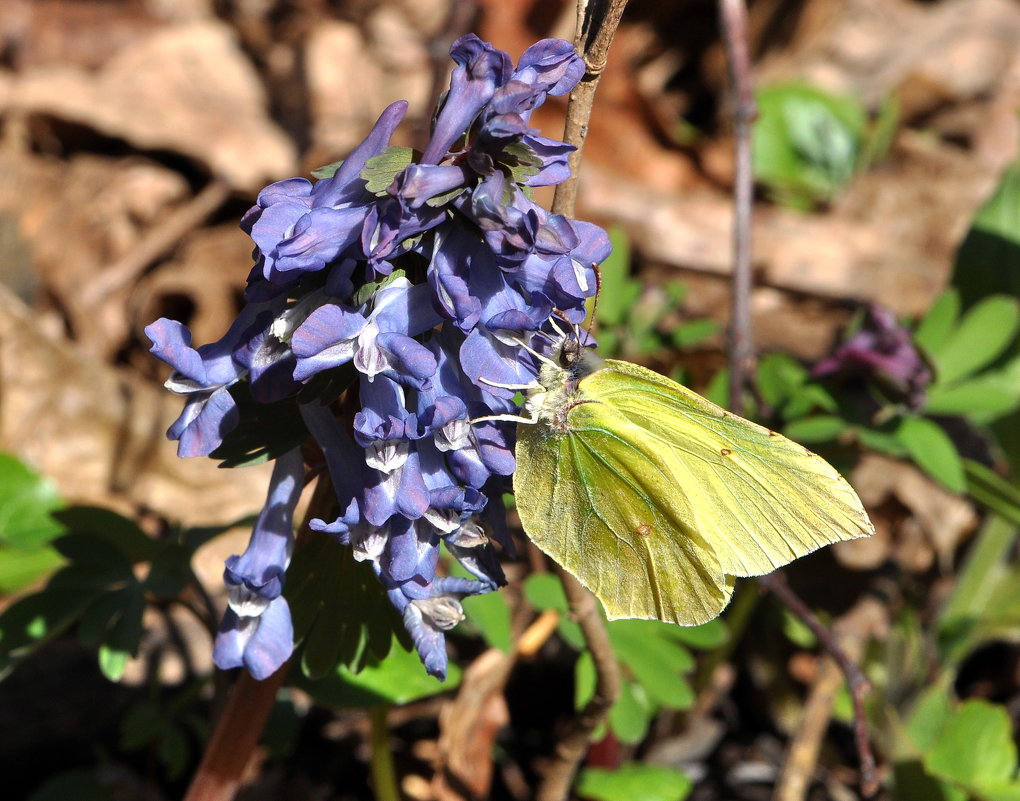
left=0, top=288, right=270, bottom=524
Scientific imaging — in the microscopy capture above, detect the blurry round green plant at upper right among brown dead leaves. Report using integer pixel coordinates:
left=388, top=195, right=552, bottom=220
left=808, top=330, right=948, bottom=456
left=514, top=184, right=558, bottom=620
left=752, top=84, right=899, bottom=210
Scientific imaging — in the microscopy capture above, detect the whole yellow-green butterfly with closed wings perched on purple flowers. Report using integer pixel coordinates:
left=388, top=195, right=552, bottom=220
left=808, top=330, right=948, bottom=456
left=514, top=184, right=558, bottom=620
left=513, top=338, right=874, bottom=625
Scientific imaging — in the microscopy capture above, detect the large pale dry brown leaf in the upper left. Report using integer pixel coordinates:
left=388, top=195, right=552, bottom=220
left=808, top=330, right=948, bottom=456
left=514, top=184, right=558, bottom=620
left=0, top=19, right=297, bottom=192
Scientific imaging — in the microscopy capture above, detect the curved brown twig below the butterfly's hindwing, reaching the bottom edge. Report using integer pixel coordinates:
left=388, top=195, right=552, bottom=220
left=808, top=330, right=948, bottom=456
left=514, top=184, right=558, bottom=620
left=536, top=569, right=620, bottom=801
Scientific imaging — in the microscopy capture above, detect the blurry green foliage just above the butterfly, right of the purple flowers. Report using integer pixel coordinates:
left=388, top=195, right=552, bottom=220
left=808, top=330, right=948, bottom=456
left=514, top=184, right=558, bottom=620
left=596, top=227, right=718, bottom=360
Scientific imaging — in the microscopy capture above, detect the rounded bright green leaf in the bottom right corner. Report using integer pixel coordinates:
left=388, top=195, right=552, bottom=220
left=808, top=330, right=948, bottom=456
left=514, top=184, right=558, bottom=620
left=924, top=700, right=1017, bottom=788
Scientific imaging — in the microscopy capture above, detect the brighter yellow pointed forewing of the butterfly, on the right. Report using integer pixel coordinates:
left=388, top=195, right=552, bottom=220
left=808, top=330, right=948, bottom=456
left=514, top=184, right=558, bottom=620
left=580, top=360, right=874, bottom=575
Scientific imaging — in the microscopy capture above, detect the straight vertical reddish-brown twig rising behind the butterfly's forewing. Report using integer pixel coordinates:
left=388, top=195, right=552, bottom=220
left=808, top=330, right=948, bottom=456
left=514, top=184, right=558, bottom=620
left=719, top=0, right=758, bottom=414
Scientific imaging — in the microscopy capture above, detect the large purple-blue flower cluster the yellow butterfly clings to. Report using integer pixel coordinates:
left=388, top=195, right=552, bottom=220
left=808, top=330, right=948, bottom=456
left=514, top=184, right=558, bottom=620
left=146, top=36, right=610, bottom=679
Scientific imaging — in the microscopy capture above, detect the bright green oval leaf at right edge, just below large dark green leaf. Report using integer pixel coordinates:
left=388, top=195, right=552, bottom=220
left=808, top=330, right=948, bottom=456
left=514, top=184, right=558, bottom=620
left=931, top=295, right=1020, bottom=384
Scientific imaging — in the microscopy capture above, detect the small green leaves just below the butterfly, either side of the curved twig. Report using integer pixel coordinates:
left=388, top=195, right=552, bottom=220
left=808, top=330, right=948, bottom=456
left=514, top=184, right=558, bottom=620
left=524, top=573, right=727, bottom=744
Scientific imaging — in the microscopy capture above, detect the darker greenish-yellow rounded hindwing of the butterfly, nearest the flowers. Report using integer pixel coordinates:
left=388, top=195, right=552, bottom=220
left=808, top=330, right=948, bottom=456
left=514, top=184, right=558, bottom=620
left=514, top=403, right=732, bottom=625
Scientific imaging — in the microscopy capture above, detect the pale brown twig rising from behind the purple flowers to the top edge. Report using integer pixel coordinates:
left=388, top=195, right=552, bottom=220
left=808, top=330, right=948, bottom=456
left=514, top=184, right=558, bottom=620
left=553, top=0, right=627, bottom=216
